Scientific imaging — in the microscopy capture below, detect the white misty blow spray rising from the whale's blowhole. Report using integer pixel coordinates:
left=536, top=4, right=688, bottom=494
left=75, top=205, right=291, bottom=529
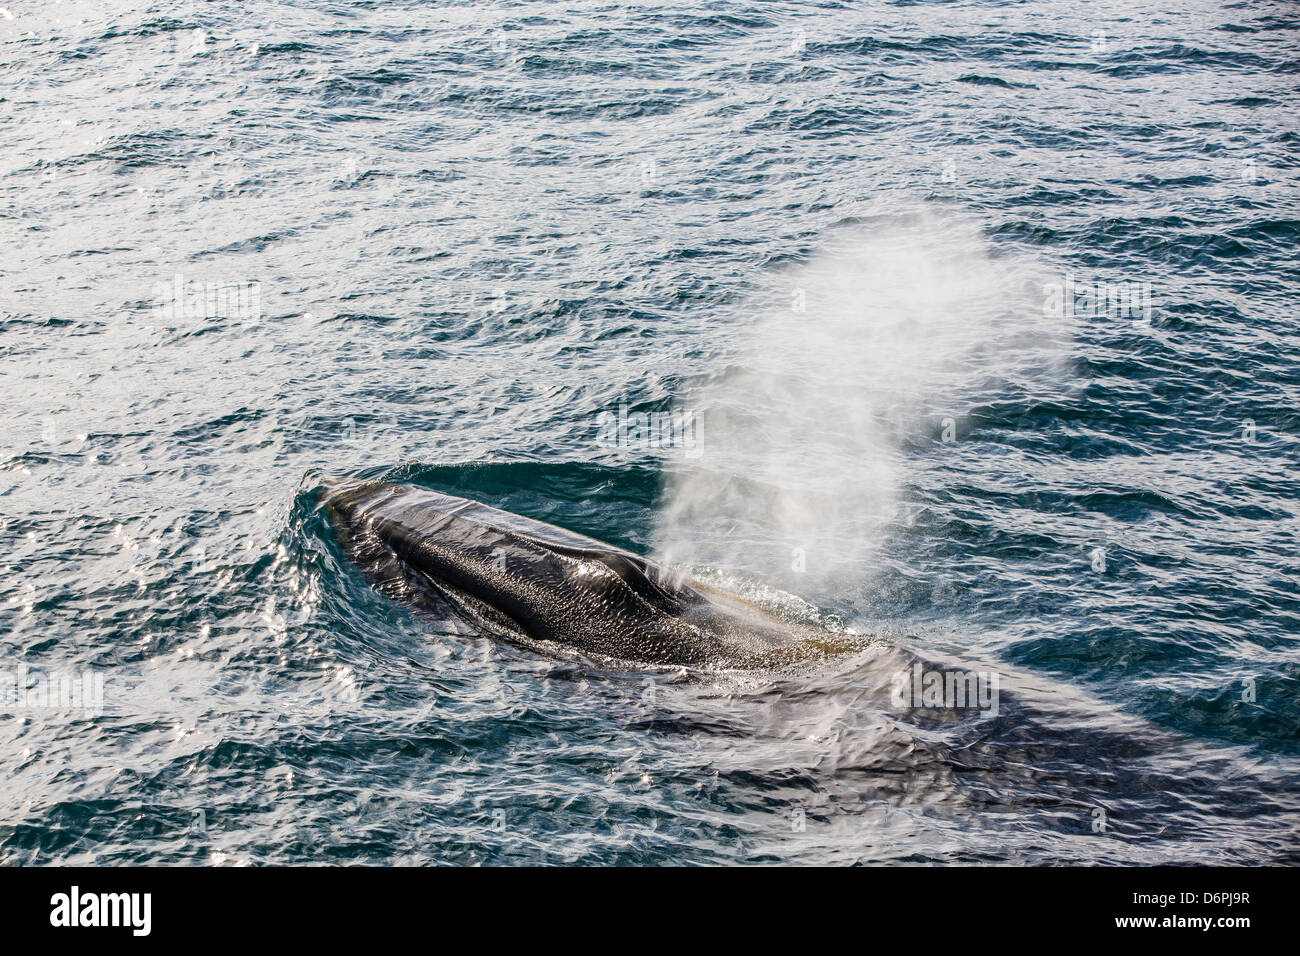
left=657, top=212, right=1049, bottom=594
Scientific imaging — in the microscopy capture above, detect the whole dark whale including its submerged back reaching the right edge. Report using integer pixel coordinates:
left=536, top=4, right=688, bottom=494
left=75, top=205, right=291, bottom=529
left=312, top=479, right=1300, bottom=865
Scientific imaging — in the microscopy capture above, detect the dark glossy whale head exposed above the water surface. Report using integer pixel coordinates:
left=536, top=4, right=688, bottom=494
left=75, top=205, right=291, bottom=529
left=319, top=479, right=857, bottom=669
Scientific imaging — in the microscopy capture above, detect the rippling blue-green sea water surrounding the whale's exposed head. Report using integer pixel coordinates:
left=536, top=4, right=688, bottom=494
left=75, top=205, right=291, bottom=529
left=0, top=0, right=1300, bottom=865
